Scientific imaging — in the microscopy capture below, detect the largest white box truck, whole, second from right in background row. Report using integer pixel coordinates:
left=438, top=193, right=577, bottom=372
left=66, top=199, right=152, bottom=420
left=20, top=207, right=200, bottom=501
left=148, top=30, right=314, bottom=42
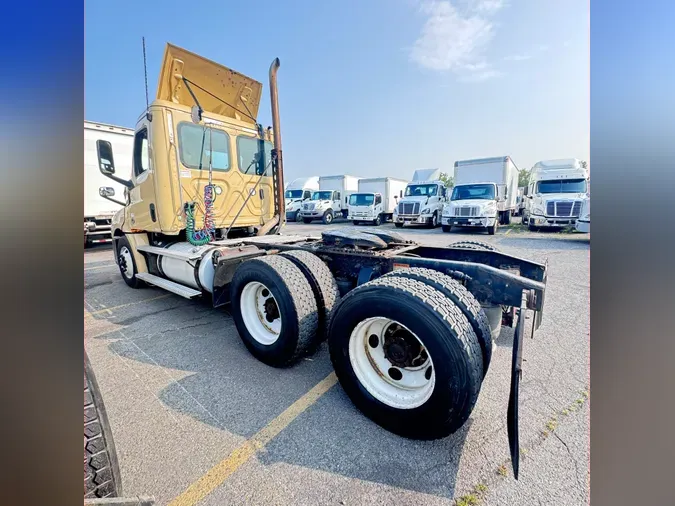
left=442, top=156, right=519, bottom=235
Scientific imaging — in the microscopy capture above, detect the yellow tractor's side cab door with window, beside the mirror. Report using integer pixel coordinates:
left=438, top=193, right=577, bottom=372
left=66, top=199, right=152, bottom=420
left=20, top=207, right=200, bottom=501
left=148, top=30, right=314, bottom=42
left=127, top=119, right=161, bottom=232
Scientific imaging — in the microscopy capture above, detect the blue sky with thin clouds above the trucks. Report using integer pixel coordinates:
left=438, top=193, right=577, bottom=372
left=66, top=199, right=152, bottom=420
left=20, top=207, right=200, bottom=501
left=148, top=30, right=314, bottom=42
left=85, top=0, right=590, bottom=180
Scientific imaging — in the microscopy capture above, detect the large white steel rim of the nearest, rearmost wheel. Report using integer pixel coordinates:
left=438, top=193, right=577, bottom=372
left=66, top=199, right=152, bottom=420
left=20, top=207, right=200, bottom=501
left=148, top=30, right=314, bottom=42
left=349, top=317, right=436, bottom=409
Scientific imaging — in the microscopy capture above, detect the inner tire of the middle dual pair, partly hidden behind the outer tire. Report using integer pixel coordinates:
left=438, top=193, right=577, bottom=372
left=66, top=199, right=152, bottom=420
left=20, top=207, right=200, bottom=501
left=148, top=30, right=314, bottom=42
left=280, top=250, right=340, bottom=341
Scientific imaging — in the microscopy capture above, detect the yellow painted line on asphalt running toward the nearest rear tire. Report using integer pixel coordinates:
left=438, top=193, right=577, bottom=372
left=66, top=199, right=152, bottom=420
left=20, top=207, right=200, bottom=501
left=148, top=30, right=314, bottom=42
left=169, top=372, right=337, bottom=506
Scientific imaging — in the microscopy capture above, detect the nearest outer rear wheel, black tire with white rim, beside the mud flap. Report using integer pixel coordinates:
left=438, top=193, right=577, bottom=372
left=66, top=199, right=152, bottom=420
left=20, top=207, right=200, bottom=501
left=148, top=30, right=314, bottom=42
left=328, top=276, right=483, bottom=439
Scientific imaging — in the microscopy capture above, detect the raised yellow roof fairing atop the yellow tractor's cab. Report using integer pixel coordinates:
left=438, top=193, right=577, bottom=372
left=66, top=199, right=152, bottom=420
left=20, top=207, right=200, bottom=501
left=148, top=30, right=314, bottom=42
left=155, top=44, right=262, bottom=125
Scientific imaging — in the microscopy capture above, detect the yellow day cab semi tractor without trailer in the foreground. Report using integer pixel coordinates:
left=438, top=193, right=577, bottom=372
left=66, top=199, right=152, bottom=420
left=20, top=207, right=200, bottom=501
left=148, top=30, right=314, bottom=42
left=97, top=45, right=547, bottom=477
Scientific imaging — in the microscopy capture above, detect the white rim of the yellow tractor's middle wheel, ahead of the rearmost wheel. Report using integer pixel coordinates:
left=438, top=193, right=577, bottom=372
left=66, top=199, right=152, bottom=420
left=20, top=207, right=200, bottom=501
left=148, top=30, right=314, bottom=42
left=239, top=281, right=281, bottom=346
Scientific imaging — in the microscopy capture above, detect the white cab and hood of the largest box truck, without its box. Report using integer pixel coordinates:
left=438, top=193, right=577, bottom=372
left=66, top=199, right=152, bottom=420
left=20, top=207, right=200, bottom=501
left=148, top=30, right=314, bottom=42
left=442, top=183, right=503, bottom=235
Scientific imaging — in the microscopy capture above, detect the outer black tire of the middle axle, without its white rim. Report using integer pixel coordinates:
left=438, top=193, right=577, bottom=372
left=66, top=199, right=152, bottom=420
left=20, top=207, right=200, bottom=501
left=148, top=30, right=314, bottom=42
left=230, top=255, right=319, bottom=367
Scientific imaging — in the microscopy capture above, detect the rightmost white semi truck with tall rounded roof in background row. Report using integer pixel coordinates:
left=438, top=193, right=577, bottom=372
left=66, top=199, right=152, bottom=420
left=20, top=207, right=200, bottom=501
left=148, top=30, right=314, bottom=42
left=523, top=158, right=589, bottom=230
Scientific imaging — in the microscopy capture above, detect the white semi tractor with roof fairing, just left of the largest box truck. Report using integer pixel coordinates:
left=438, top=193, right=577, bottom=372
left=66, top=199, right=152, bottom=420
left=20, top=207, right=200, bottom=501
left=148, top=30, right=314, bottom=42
left=394, top=169, right=447, bottom=228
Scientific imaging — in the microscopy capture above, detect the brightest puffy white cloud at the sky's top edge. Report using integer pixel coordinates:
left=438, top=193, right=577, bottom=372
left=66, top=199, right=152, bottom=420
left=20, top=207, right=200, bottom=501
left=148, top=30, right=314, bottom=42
left=410, top=0, right=504, bottom=82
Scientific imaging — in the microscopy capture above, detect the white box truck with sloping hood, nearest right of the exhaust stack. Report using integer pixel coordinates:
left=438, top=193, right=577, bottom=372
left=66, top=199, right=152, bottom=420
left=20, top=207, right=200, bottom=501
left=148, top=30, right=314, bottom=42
left=300, top=175, right=361, bottom=225
